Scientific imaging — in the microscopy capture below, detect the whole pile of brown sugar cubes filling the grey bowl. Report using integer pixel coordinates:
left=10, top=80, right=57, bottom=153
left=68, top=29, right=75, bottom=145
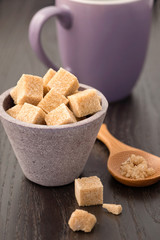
left=7, top=68, right=101, bottom=125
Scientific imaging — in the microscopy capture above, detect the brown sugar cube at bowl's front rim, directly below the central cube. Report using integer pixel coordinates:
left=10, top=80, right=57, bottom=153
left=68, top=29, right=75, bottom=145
left=45, top=103, right=77, bottom=125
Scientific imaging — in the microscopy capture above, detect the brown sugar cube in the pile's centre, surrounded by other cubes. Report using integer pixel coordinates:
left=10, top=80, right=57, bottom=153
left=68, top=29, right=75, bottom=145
left=38, top=88, right=68, bottom=113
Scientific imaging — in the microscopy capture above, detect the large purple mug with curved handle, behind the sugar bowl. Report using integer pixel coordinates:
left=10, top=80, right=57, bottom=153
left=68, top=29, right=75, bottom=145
left=29, top=0, right=153, bottom=102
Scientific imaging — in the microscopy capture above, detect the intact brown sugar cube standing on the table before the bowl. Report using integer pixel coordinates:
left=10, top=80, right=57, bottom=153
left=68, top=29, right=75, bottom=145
left=75, top=176, right=103, bottom=206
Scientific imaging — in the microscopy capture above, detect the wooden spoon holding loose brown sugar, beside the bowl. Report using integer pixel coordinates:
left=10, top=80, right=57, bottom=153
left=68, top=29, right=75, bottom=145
left=97, top=124, right=160, bottom=187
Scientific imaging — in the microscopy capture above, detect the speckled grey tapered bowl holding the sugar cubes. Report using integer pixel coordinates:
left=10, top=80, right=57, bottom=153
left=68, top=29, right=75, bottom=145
left=0, top=84, right=108, bottom=186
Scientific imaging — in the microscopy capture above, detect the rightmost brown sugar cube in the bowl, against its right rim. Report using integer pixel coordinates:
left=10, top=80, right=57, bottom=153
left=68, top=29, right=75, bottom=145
left=68, top=89, right=102, bottom=117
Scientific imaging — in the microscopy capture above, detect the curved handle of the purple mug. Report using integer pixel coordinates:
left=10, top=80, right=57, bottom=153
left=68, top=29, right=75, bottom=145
left=29, top=6, right=72, bottom=71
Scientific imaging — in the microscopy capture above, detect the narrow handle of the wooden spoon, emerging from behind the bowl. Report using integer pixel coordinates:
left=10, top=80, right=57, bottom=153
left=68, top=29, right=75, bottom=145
left=97, top=123, right=129, bottom=155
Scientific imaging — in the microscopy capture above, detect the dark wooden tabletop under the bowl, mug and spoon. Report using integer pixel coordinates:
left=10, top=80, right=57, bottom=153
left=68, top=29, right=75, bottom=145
left=0, top=0, right=160, bottom=240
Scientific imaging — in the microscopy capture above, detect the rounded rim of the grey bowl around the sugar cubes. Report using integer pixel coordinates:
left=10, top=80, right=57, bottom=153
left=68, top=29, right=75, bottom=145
left=0, top=84, right=108, bottom=130
